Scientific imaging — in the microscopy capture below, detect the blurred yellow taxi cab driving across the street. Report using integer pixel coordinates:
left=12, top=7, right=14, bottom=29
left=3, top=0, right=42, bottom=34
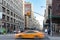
left=15, top=30, right=45, bottom=38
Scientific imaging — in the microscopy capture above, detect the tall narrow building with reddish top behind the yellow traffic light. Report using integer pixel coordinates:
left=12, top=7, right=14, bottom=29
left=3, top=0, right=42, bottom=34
left=24, top=2, right=32, bottom=27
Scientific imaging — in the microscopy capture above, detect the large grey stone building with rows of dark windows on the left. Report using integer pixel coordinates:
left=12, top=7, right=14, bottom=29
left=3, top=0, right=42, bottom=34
left=0, top=0, right=24, bottom=32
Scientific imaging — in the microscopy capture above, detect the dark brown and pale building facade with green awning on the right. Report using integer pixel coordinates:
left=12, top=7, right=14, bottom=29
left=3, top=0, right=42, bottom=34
left=44, top=0, right=60, bottom=33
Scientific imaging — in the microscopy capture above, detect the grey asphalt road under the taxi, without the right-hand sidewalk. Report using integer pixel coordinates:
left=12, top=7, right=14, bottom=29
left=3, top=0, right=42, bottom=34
left=0, top=34, right=49, bottom=40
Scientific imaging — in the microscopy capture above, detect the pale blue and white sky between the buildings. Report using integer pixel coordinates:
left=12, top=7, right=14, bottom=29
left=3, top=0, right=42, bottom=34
left=25, top=0, right=46, bottom=25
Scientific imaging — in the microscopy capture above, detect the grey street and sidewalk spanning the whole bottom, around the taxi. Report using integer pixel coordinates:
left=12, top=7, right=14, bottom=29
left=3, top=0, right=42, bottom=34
left=0, top=34, right=60, bottom=40
